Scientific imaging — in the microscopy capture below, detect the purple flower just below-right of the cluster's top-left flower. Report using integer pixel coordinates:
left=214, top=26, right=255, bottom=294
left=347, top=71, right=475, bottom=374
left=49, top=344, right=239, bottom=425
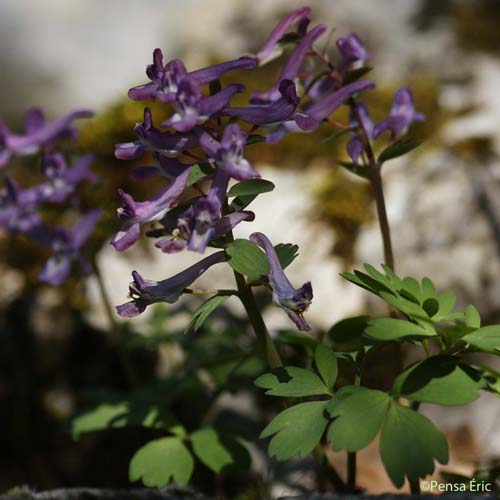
left=161, top=79, right=244, bottom=132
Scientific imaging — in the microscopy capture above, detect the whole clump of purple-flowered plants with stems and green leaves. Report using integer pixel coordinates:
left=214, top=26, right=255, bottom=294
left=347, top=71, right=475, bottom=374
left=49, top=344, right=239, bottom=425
left=0, top=7, right=500, bottom=492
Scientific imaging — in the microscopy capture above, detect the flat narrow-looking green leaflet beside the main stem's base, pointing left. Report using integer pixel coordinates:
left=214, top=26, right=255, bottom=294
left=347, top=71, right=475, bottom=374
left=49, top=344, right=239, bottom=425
left=254, top=366, right=331, bottom=398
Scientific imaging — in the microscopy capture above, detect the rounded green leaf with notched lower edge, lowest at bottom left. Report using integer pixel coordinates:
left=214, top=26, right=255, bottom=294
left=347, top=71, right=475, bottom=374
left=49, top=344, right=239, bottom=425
left=129, top=437, right=193, bottom=487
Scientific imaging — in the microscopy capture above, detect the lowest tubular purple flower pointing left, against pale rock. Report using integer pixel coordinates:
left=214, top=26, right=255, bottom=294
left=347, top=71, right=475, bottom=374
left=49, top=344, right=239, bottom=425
left=116, top=252, right=226, bottom=318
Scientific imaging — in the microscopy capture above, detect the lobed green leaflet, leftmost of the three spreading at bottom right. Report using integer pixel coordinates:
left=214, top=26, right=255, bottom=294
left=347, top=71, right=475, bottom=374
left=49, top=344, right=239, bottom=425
left=260, top=401, right=328, bottom=460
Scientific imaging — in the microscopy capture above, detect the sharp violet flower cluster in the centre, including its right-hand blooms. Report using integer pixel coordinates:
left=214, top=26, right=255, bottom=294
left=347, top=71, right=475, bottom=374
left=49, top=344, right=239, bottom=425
left=111, top=7, right=422, bottom=331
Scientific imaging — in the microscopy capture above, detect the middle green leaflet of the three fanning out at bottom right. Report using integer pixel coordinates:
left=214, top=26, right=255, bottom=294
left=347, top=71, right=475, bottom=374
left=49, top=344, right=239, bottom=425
left=327, top=386, right=391, bottom=451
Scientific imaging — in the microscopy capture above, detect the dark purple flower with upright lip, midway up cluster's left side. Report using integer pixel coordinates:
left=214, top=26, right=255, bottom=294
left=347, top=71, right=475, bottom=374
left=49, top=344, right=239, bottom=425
left=115, top=108, right=198, bottom=160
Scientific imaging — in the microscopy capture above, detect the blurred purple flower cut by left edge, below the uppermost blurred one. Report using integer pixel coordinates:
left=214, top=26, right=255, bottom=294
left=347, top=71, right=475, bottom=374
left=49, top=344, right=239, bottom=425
left=0, top=176, right=42, bottom=233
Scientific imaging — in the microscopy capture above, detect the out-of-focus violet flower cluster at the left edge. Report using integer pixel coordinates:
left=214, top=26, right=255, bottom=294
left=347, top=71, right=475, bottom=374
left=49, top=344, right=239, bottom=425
left=0, top=108, right=101, bottom=286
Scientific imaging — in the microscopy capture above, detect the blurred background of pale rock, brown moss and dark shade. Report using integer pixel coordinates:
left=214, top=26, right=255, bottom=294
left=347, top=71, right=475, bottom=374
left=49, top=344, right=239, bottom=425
left=0, top=0, right=500, bottom=492
